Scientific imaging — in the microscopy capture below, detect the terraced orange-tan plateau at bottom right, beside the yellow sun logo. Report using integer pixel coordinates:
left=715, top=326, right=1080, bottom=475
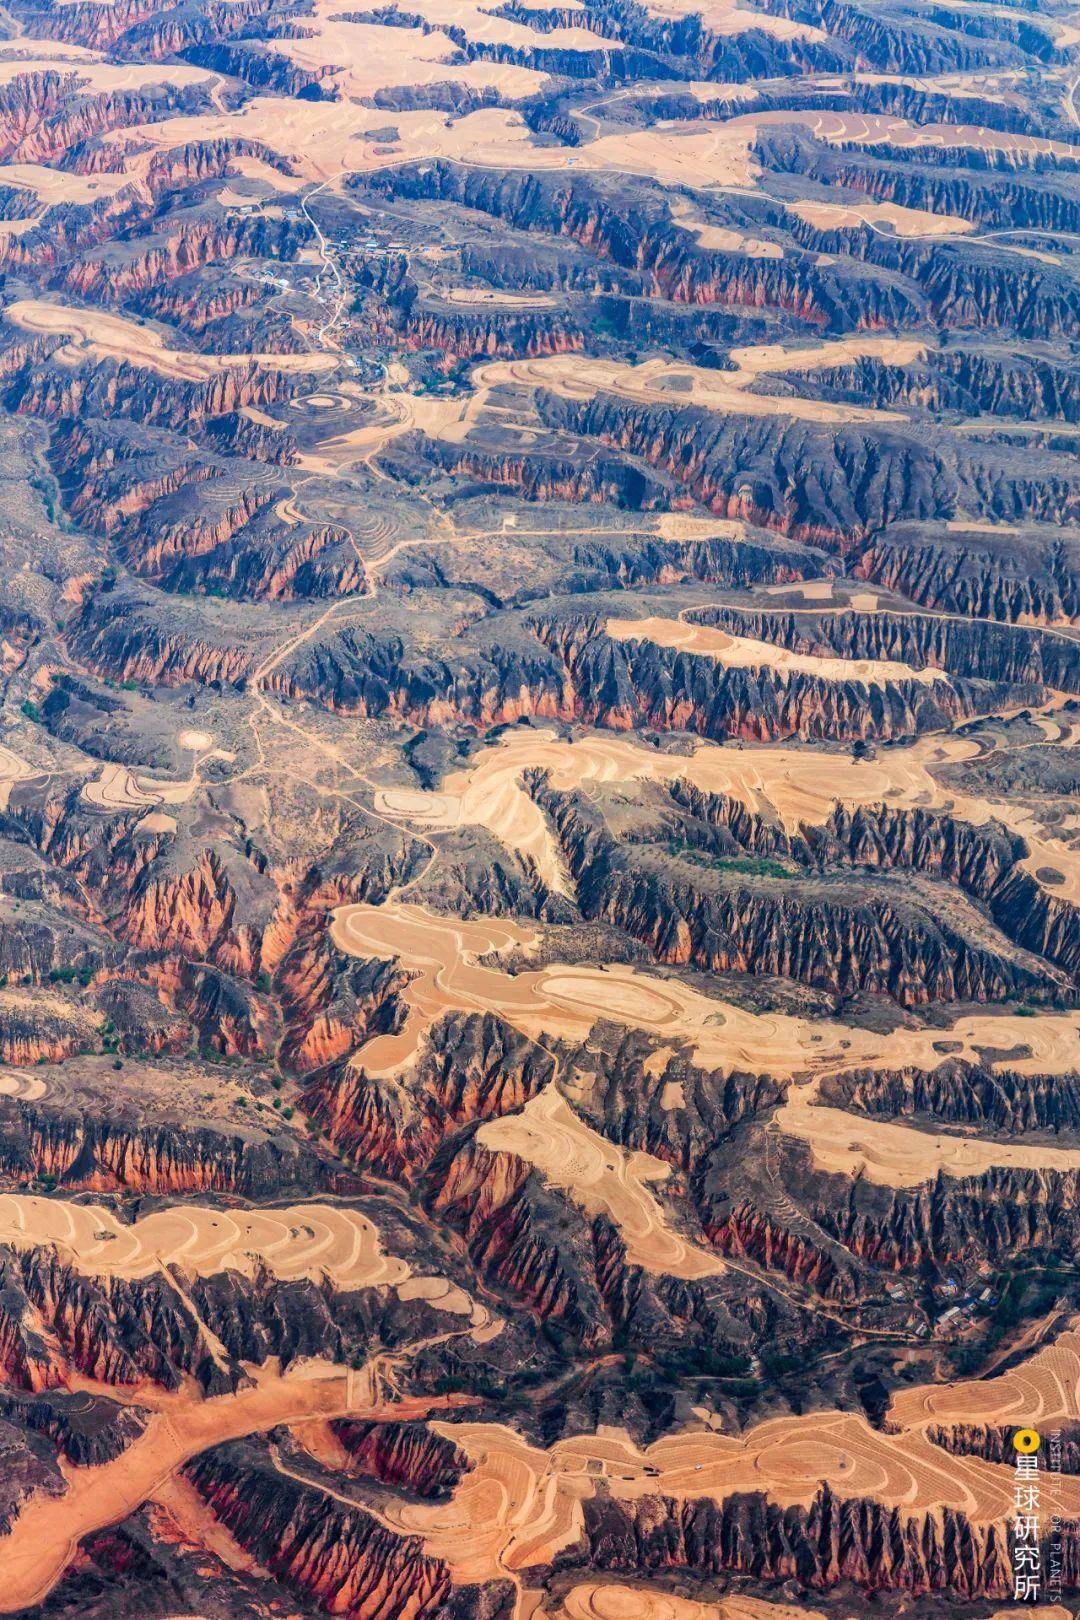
left=356, top=1332, right=1080, bottom=1594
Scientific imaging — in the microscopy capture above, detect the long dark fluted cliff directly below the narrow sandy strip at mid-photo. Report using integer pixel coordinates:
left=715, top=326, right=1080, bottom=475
left=234, top=611, right=1029, bottom=742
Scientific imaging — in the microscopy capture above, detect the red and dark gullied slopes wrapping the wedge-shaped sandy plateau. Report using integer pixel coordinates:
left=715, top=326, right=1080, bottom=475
left=303, top=1016, right=803, bottom=1359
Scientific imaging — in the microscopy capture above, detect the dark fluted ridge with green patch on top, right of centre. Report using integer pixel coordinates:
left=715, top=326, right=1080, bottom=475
left=536, top=787, right=1075, bottom=1006
